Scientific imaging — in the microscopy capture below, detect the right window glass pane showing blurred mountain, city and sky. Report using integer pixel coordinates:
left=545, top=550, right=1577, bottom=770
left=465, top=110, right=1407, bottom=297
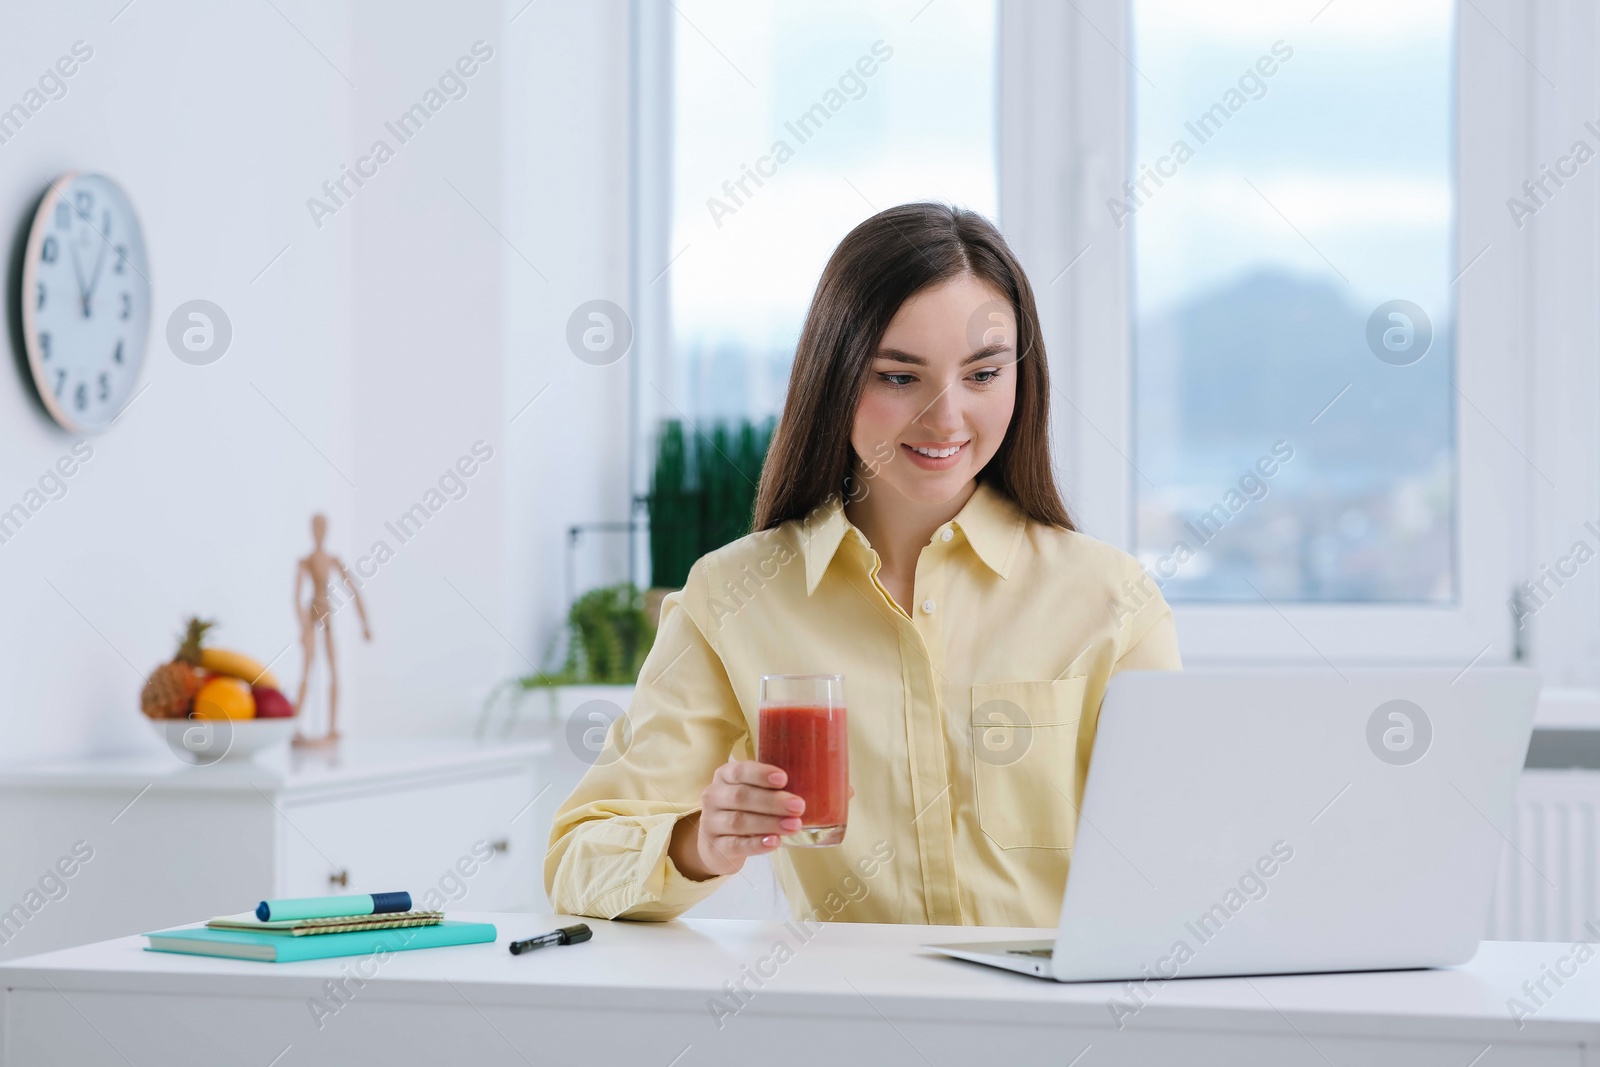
left=1126, top=0, right=1459, bottom=605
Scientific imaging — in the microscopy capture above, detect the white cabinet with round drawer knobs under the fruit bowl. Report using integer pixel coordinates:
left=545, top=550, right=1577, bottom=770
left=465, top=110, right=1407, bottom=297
left=0, top=739, right=549, bottom=958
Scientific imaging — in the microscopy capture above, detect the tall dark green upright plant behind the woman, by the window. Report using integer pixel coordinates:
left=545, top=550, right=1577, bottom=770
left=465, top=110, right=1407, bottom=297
left=648, top=419, right=776, bottom=589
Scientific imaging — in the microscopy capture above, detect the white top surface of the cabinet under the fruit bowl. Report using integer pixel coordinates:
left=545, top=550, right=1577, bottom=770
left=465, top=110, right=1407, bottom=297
left=0, top=737, right=550, bottom=790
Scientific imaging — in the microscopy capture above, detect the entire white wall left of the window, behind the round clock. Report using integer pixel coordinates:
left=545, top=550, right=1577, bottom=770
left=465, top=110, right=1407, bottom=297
left=0, top=0, right=627, bottom=761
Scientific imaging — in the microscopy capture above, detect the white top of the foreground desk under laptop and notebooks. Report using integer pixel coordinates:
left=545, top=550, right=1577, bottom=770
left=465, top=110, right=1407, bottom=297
left=0, top=912, right=1600, bottom=1043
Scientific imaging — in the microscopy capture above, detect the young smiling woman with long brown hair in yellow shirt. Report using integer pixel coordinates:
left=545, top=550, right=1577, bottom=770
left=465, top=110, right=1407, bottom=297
left=546, top=203, right=1179, bottom=926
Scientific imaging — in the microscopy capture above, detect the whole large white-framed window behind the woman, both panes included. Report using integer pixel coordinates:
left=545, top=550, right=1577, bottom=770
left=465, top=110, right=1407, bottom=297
left=634, top=0, right=1542, bottom=677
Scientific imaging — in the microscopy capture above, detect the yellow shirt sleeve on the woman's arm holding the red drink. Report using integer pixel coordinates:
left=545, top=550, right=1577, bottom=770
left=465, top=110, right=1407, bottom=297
left=544, top=560, right=747, bottom=920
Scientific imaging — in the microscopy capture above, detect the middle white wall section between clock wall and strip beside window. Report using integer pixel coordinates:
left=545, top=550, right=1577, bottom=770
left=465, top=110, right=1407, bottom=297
left=345, top=2, right=510, bottom=733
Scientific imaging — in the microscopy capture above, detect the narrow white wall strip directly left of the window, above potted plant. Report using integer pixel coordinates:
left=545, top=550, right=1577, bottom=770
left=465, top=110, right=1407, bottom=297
left=490, top=0, right=643, bottom=716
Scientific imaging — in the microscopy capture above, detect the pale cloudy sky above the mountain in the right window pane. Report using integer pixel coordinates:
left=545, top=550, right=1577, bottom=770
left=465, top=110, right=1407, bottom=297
left=1131, top=0, right=1454, bottom=318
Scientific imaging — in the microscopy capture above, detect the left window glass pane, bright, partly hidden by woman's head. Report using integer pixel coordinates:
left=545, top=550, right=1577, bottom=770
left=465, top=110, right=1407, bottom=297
left=656, top=0, right=997, bottom=427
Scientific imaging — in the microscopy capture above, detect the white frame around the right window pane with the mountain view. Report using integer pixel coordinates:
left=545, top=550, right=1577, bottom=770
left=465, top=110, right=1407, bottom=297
left=1000, top=0, right=1531, bottom=670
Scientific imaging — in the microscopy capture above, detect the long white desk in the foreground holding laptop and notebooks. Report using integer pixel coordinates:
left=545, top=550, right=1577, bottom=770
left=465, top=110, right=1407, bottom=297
left=0, top=913, right=1600, bottom=1067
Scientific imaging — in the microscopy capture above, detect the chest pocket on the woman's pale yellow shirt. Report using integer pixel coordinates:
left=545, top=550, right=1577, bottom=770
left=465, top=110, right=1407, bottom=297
left=973, top=678, right=1086, bottom=848
